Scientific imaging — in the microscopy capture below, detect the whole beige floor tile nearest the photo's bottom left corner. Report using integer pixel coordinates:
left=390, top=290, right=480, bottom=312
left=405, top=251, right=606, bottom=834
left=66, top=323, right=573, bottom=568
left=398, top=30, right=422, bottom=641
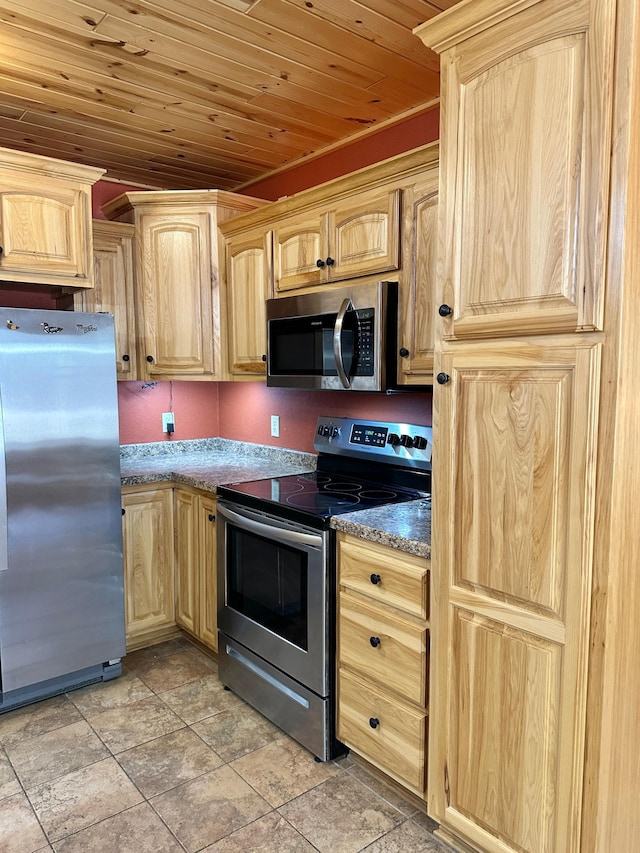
left=29, top=758, right=142, bottom=842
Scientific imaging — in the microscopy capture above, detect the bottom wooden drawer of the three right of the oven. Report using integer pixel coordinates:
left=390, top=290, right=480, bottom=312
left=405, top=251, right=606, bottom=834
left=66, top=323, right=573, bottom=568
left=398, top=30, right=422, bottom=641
left=338, top=670, right=427, bottom=794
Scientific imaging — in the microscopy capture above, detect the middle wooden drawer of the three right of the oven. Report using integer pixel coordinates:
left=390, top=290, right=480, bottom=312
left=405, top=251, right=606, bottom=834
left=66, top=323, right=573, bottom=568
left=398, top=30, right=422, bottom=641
left=338, top=594, right=427, bottom=705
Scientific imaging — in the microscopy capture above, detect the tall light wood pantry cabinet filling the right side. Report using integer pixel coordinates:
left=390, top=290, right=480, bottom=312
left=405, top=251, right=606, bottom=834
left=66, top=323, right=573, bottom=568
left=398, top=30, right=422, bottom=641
left=416, top=0, right=640, bottom=853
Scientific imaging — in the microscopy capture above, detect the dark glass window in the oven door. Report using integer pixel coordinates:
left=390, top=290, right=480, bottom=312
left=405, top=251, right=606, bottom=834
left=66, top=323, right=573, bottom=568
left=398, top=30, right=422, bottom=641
left=227, top=525, right=308, bottom=651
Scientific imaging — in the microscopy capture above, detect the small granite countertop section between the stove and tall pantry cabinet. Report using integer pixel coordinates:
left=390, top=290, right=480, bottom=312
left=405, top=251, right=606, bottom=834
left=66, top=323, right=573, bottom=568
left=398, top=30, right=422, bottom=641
left=331, top=498, right=431, bottom=559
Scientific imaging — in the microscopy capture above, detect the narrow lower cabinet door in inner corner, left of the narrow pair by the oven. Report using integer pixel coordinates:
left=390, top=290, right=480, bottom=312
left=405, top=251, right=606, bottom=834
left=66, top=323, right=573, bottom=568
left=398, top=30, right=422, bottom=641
left=173, top=489, right=199, bottom=636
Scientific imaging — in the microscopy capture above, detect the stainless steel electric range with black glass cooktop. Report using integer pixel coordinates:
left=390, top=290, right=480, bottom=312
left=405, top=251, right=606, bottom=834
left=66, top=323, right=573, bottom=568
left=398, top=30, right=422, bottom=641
left=218, top=417, right=431, bottom=760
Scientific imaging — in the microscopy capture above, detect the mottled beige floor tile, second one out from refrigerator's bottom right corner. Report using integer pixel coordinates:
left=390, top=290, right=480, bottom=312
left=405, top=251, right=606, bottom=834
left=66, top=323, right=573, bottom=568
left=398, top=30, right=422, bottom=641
left=87, top=696, right=184, bottom=753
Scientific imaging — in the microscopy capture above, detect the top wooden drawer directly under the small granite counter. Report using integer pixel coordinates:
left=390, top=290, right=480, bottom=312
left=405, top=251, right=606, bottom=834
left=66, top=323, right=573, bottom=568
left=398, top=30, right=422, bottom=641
left=338, top=538, right=429, bottom=619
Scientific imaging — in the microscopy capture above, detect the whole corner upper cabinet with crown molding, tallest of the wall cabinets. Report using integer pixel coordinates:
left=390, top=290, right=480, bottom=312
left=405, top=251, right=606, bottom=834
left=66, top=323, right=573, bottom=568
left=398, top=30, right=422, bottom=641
left=103, top=190, right=260, bottom=379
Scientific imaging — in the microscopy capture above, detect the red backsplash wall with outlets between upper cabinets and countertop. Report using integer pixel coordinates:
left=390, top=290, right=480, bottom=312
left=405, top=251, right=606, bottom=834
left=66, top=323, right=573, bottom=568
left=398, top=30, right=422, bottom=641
left=118, top=382, right=431, bottom=452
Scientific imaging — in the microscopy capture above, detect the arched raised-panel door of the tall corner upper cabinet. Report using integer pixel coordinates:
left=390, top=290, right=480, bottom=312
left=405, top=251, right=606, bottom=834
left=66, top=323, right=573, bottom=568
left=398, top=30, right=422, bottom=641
left=136, top=212, right=214, bottom=379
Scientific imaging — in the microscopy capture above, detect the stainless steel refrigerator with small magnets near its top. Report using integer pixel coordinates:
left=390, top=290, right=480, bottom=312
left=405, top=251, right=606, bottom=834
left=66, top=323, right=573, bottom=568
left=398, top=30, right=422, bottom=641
left=0, top=308, right=125, bottom=712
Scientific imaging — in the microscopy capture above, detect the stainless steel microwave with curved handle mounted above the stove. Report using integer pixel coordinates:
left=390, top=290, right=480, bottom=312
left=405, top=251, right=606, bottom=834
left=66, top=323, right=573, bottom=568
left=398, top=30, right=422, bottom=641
left=267, top=281, right=398, bottom=391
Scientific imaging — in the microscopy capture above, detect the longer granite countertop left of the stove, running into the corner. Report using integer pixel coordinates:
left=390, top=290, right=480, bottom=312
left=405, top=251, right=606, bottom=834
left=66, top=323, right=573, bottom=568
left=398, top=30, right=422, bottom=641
left=120, top=438, right=316, bottom=492
